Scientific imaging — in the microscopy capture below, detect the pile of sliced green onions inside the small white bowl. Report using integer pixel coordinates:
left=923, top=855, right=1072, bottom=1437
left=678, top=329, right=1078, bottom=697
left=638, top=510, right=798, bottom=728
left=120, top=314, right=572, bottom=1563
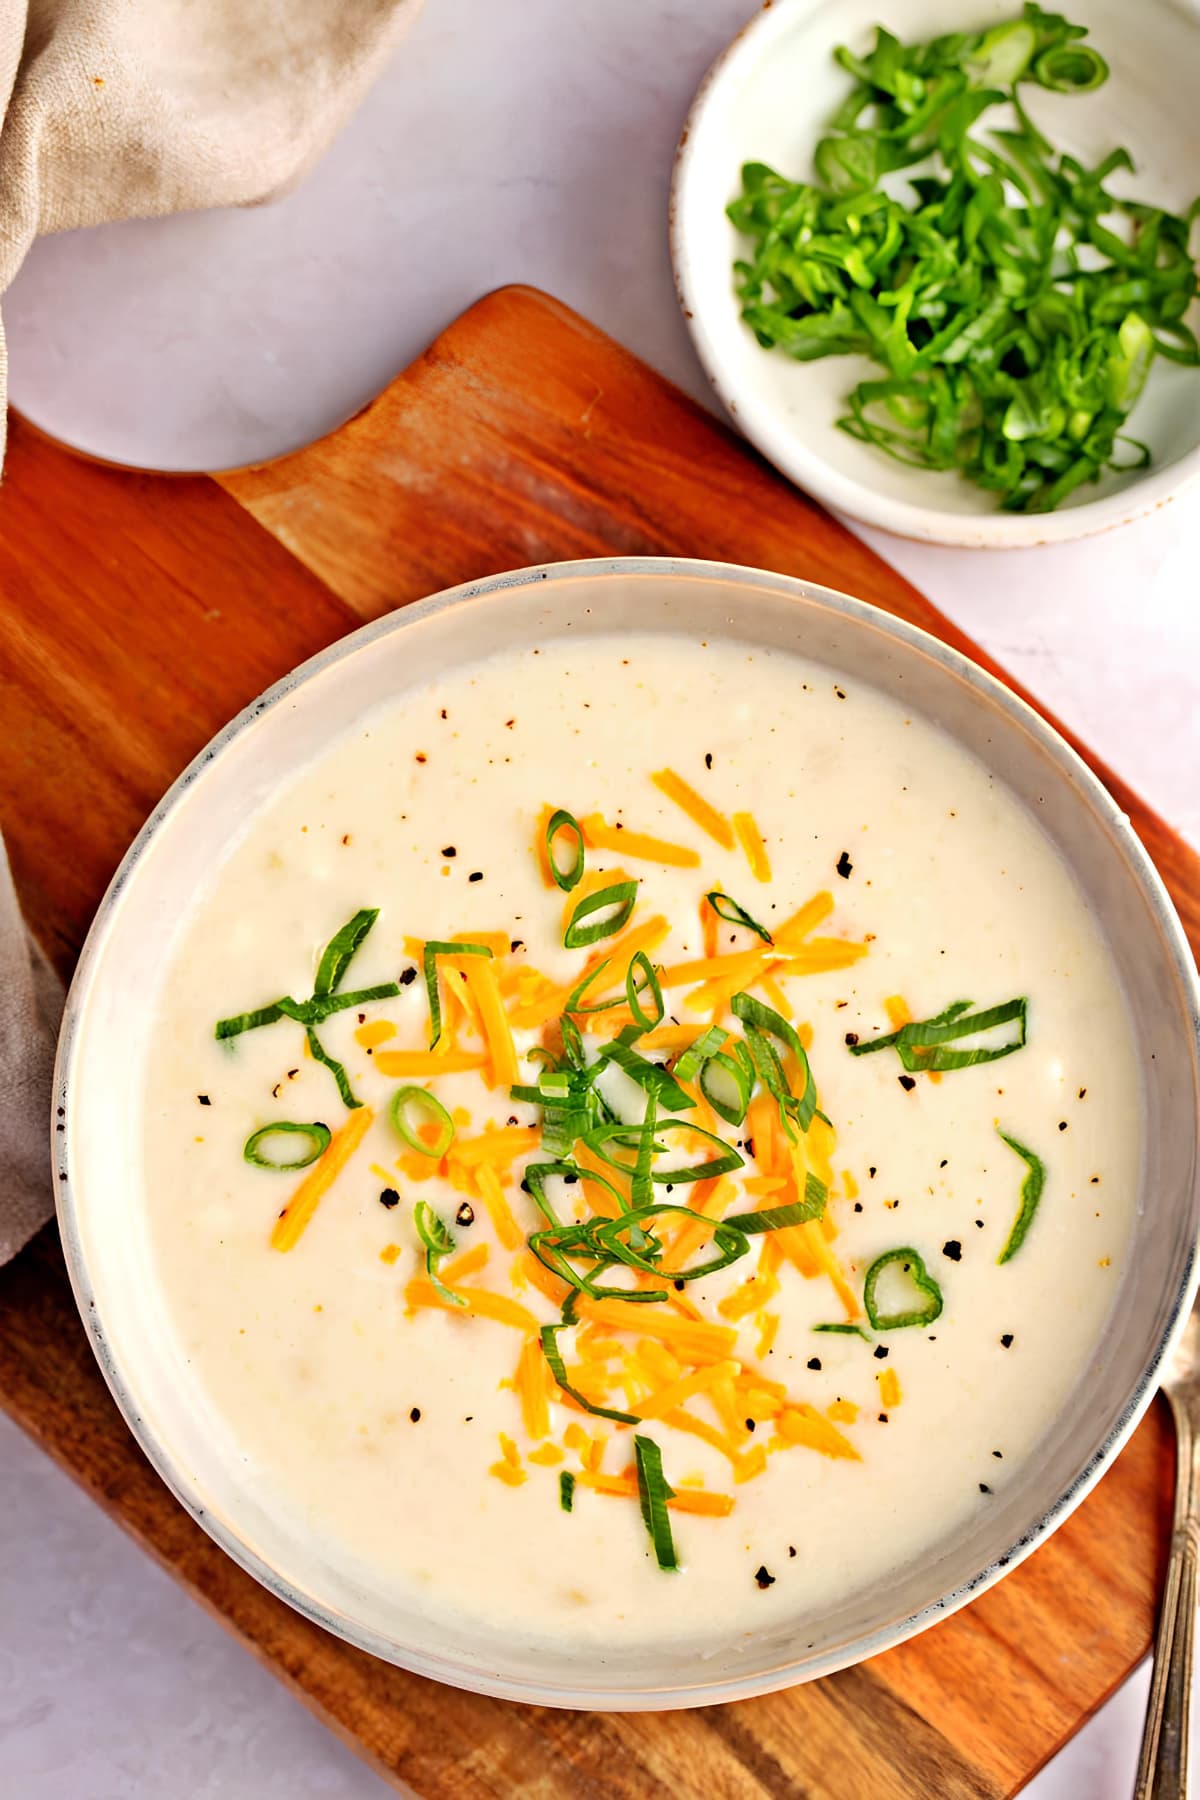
left=727, top=4, right=1200, bottom=513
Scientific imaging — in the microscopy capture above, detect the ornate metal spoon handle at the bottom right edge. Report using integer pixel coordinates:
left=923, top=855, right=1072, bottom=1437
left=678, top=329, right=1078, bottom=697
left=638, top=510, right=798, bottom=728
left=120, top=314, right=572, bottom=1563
left=1133, top=1395, right=1200, bottom=1800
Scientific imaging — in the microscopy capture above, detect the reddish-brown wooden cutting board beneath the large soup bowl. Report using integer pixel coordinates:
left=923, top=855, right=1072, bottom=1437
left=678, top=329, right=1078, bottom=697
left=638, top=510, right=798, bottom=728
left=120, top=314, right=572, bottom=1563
left=0, top=288, right=1200, bottom=1800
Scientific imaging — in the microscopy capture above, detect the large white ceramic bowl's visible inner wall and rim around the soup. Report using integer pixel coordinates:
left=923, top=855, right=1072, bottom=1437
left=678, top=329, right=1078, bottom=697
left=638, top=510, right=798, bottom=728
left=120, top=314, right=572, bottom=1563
left=54, top=558, right=1200, bottom=1708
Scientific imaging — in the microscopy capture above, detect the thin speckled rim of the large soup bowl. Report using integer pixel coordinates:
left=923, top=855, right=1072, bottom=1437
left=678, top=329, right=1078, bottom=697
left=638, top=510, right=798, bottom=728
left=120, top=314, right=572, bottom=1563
left=50, top=556, right=1200, bottom=1712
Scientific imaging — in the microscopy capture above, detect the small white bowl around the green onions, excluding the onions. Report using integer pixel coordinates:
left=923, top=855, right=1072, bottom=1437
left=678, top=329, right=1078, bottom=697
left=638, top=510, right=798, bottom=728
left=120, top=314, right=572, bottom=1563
left=671, top=0, right=1200, bottom=549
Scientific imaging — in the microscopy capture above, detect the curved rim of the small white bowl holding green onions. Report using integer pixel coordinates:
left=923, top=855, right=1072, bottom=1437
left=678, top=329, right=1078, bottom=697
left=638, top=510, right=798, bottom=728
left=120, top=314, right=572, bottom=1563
left=667, top=0, right=1200, bottom=549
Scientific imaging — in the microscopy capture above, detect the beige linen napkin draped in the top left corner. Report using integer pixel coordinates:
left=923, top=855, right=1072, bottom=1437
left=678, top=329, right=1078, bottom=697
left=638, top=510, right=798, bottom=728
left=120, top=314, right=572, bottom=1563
left=0, top=0, right=421, bottom=461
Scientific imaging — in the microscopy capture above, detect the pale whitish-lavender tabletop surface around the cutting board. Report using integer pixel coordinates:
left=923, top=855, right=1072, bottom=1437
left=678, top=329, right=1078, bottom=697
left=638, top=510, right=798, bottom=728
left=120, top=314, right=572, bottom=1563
left=0, top=0, right=1200, bottom=1800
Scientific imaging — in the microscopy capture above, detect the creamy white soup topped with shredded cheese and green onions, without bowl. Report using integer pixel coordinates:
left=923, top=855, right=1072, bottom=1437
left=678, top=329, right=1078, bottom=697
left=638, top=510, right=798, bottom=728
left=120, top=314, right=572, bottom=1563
left=142, top=635, right=1139, bottom=1645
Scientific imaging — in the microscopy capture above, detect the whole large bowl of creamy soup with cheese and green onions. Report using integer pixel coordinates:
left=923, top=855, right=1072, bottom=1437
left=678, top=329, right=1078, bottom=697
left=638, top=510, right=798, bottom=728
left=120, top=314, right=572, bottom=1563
left=56, top=560, right=1198, bottom=1708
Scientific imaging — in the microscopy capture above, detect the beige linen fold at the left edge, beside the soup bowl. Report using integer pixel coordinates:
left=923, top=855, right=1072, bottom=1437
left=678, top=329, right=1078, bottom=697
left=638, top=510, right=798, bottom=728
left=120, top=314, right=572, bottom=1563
left=0, top=839, right=63, bottom=1265
